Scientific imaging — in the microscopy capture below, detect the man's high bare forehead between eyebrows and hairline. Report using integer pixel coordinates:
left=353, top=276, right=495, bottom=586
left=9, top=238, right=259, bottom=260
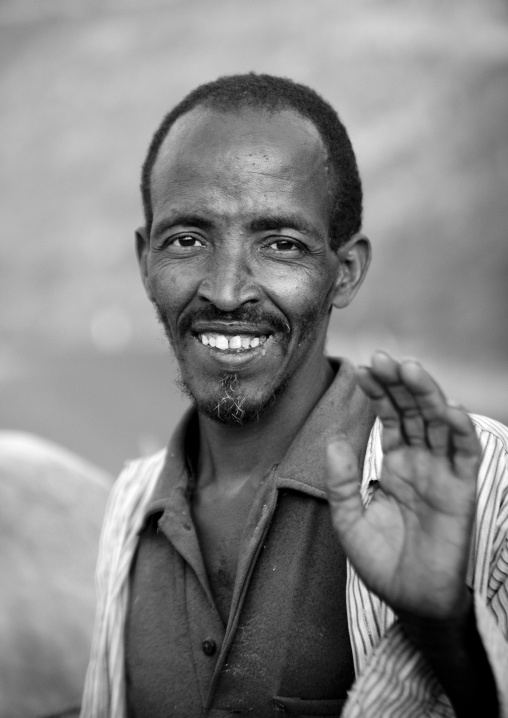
left=151, top=107, right=328, bottom=221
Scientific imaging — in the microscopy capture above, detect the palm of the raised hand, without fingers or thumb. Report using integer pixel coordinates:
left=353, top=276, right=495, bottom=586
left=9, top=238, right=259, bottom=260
left=348, top=447, right=474, bottom=617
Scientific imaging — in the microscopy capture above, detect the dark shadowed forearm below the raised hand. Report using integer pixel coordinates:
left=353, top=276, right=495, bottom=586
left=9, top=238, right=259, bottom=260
left=399, top=600, right=499, bottom=718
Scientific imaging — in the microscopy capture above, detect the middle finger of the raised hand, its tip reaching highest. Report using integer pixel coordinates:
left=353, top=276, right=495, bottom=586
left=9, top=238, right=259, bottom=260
left=372, top=351, right=426, bottom=446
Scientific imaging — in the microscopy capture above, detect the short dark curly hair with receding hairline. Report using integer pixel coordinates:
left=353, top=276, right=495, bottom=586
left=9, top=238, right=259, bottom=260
left=141, top=72, right=362, bottom=249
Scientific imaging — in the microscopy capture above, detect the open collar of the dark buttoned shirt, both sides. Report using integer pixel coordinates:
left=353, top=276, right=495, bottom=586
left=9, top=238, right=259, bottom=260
left=145, top=358, right=375, bottom=517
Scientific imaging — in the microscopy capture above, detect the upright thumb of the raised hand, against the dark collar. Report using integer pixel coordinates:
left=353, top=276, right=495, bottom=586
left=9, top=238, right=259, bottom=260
left=326, top=437, right=364, bottom=534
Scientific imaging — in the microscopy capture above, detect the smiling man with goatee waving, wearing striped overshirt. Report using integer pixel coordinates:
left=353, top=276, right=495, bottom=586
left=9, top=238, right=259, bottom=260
left=82, top=74, right=508, bottom=718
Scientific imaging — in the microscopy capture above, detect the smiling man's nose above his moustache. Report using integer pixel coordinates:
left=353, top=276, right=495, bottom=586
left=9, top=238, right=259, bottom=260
left=198, top=248, right=261, bottom=312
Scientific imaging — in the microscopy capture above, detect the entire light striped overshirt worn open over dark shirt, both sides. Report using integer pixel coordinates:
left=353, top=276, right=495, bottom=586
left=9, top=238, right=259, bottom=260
left=81, top=415, right=508, bottom=718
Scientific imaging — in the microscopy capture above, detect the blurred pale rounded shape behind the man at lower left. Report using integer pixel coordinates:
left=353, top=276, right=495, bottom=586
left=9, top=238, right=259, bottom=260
left=0, top=431, right=113, bottom=718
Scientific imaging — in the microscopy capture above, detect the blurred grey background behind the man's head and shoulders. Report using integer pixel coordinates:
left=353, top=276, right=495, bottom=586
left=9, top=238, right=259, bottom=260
left=0, top=0, right=508, bottom=474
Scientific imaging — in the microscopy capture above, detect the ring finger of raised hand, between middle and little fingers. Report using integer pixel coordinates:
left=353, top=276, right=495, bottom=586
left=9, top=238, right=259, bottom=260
left=399, top=359, right=450, bottom=456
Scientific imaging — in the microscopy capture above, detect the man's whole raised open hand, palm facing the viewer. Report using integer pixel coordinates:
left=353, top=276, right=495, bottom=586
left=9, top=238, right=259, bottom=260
left=328, top=352, right=481, bottom=621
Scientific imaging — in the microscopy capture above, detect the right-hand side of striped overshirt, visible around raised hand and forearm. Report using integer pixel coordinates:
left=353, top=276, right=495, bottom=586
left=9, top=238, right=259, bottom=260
left=343, top=415, right=508, bottom=718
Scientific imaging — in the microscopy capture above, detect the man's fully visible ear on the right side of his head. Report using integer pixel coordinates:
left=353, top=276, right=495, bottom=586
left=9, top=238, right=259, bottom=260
left=332, top=232, right=371, bottom=309
